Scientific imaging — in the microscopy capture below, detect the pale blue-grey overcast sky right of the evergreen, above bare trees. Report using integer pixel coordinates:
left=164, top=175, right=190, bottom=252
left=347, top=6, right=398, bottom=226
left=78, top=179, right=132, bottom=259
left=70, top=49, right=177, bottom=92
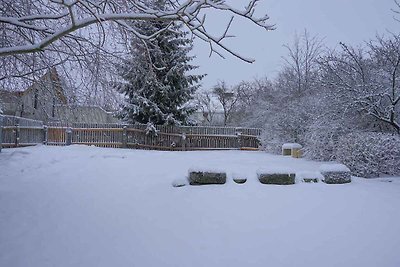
left=193, top=0, right=400, bottom=89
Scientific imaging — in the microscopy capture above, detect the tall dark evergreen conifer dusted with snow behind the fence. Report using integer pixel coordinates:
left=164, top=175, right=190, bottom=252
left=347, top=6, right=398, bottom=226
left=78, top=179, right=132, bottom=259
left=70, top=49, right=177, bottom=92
left=115, top=1, right=204, bottom=125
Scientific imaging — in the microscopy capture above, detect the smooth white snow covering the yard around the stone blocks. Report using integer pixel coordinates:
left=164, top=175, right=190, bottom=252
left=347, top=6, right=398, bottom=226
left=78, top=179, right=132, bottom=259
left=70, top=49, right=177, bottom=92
left=0, top=146, right=400, bottom=267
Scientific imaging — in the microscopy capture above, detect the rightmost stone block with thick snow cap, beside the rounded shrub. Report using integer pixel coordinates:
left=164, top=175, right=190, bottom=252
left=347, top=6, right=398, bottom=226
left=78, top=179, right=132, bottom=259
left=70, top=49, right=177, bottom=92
left=319, top=164, right=351, bottom=184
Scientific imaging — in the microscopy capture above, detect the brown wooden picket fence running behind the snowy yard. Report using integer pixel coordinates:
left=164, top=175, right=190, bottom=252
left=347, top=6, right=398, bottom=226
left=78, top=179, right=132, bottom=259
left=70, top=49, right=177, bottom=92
left=0, top=116, right=261, bottom=150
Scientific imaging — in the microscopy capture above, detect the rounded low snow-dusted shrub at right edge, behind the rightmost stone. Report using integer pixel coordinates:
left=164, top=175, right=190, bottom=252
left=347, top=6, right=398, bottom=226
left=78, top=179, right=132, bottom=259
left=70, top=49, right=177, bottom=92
left=336, top=132, right=400, bottom=177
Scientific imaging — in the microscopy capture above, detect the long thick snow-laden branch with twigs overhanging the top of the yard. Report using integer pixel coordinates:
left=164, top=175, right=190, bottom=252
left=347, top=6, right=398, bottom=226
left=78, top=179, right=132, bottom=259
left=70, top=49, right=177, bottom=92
left=0, top=0, right=274, bottom=62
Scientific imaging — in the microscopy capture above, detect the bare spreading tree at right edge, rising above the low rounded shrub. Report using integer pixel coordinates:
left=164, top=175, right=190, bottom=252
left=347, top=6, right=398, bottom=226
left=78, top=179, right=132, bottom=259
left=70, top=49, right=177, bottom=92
left=322, top=35, right=400, bottom=134
